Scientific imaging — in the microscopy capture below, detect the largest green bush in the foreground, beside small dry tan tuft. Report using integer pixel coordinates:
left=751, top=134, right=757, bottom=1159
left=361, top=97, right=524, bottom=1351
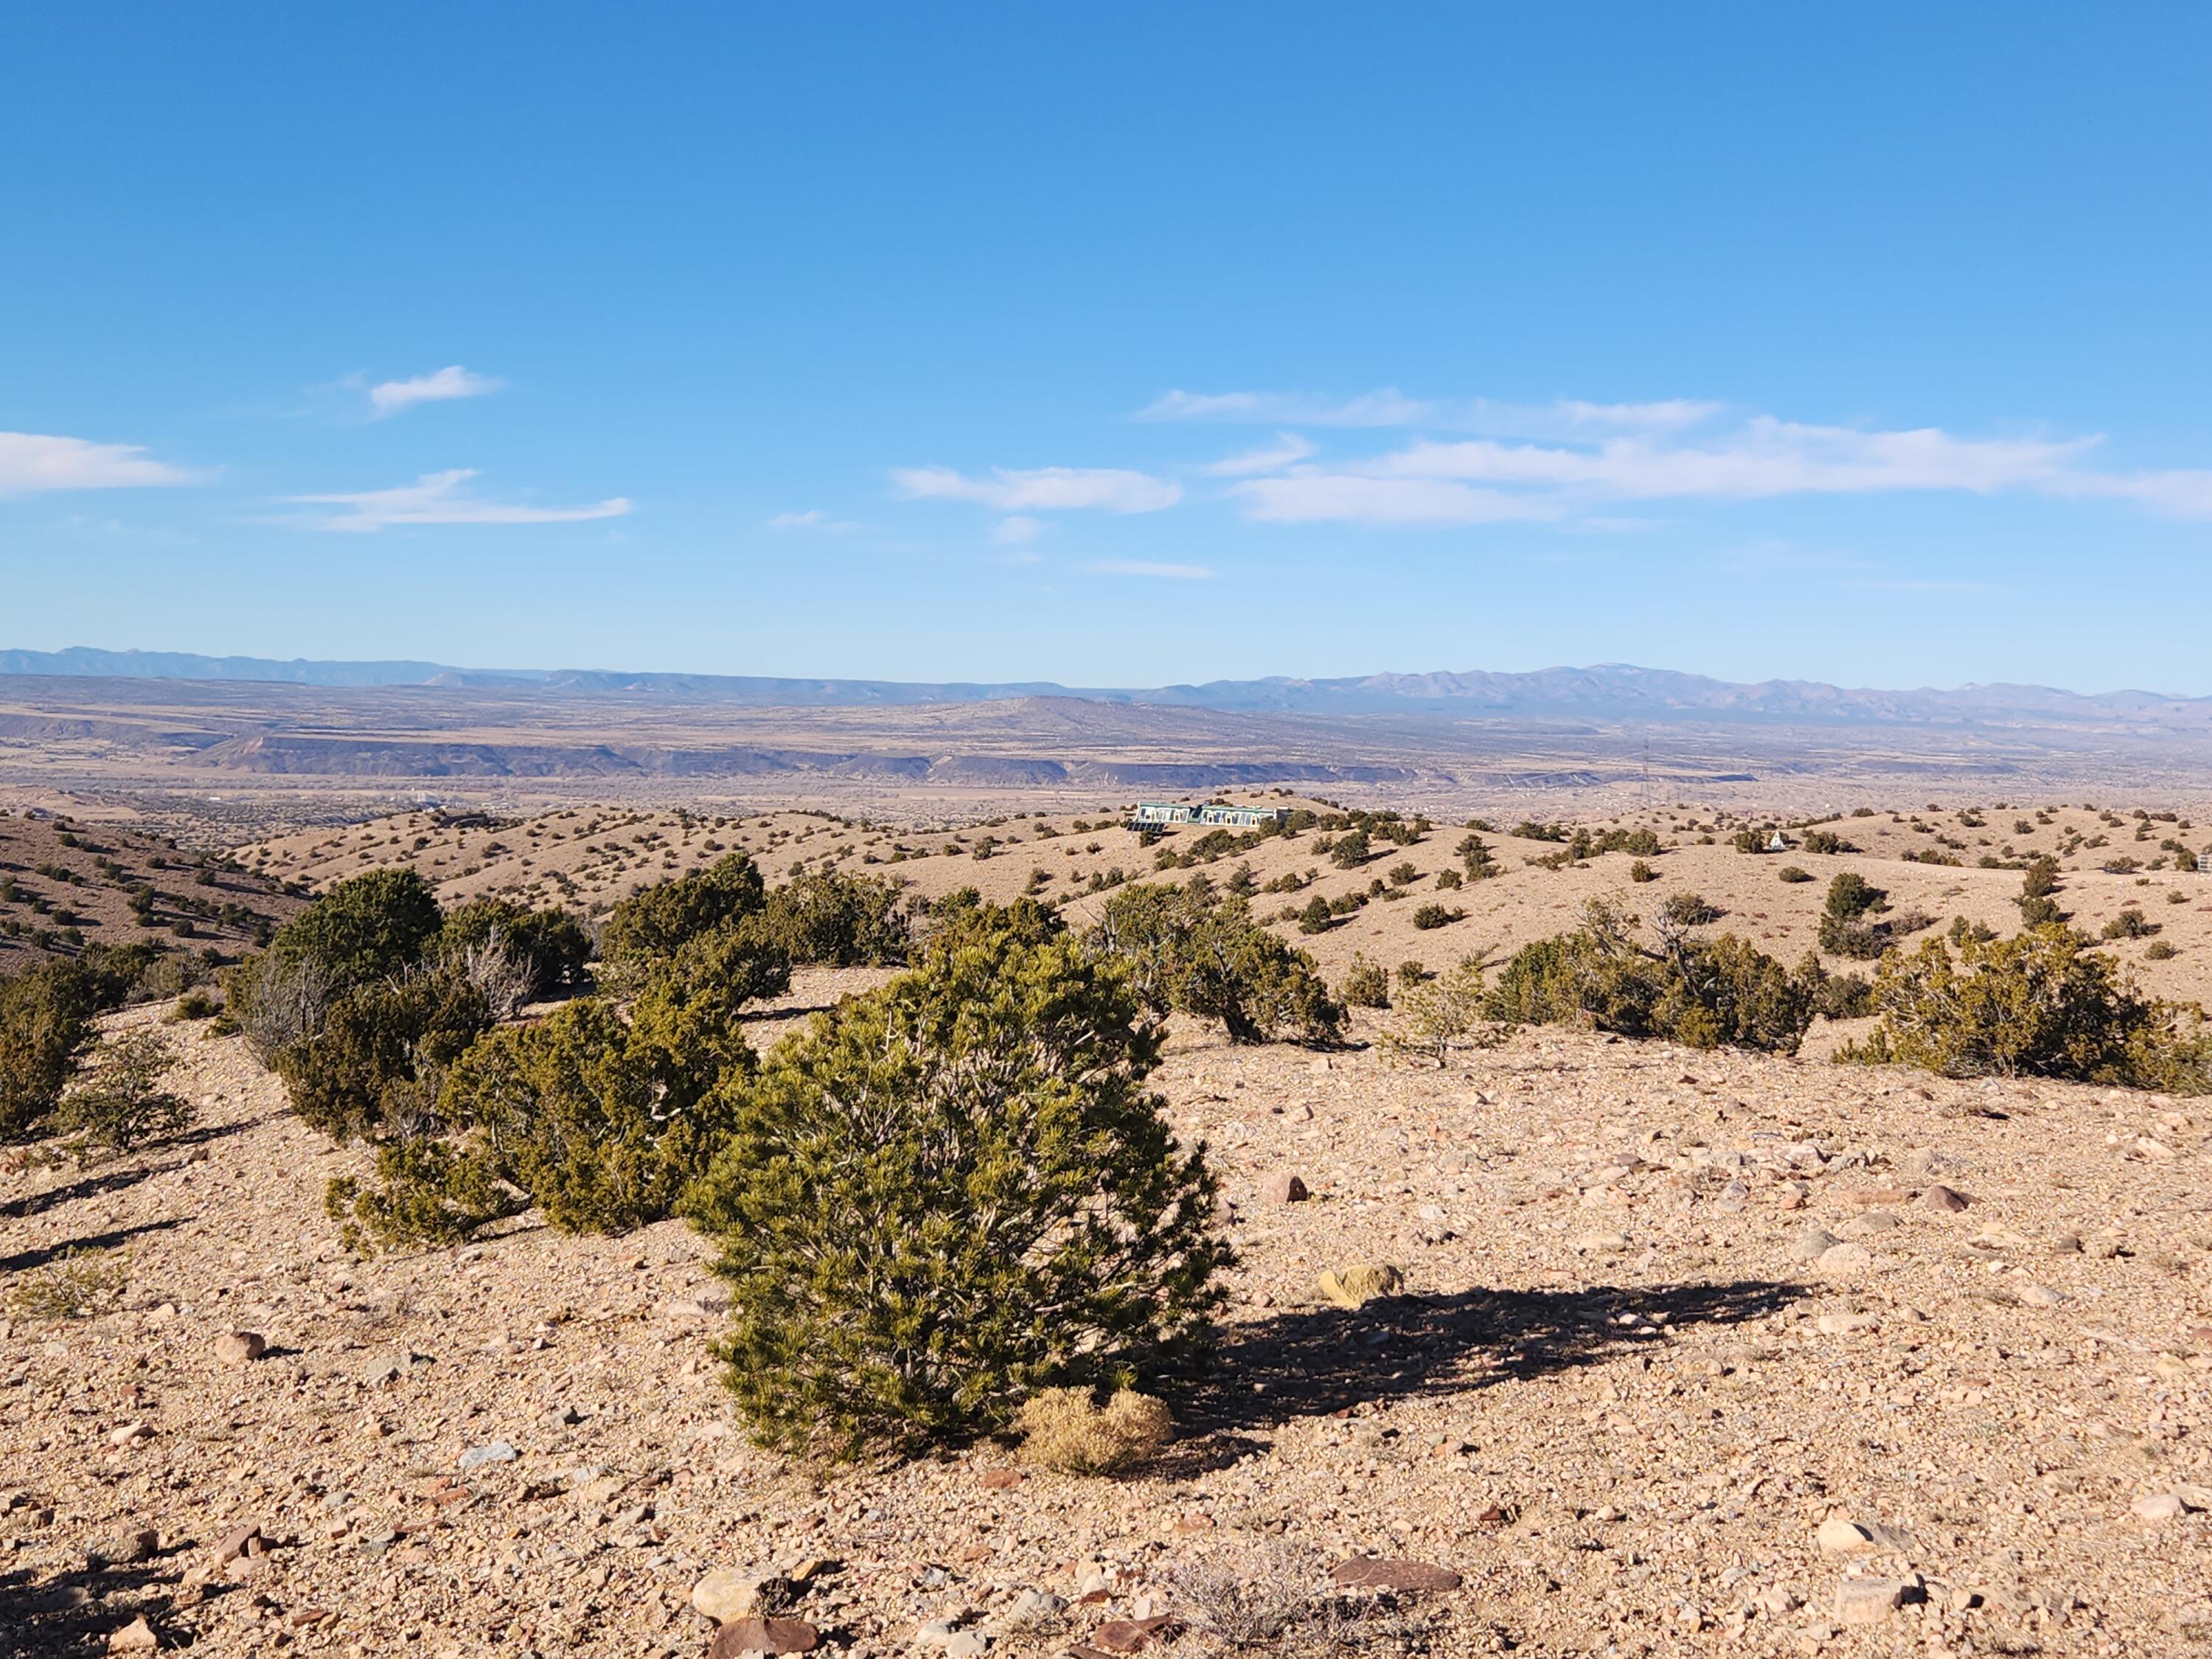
left=690, top=911, right=1230, bottom=1455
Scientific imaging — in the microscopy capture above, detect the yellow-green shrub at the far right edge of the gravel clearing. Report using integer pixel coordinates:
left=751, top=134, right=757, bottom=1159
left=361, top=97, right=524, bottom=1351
left=1838, top=925, right=2212, bottom=1095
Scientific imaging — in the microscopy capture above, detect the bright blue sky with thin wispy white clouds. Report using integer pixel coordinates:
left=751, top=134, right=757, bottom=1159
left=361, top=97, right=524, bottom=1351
left=0, top=2, right=2212, bottom=692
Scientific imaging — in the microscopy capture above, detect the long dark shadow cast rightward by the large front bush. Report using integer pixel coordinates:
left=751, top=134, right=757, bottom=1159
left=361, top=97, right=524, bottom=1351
left=1177, top=1279, right=1805, bottom=1436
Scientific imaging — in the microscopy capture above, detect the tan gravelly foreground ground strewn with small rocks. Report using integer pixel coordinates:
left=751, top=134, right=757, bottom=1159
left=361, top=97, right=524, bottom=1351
left=0, top=975, right=2212, bottom=1659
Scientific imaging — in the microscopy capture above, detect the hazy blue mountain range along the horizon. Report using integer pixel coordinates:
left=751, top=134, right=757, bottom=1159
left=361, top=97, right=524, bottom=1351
left=0, top=646, right=2212, bottom=730
